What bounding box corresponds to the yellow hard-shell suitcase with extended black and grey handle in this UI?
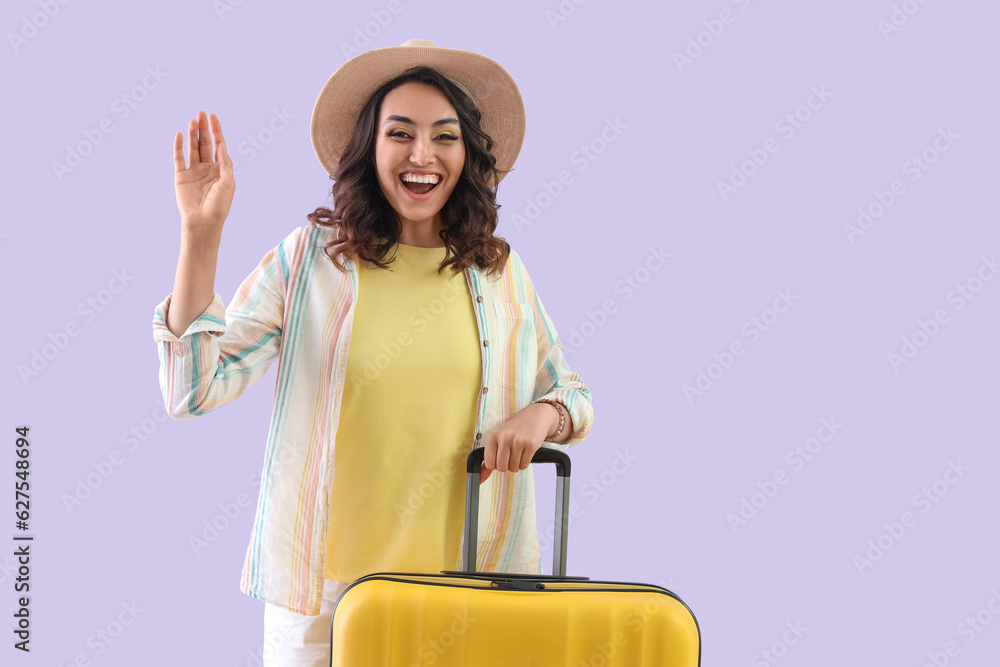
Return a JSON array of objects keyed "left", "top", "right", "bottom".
[{"left": 330, "top": 447, "right": 701, "bottom": 667}]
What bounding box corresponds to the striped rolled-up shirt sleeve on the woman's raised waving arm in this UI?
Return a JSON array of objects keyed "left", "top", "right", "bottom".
[{"left": 153, "top": 239, "right": 288, "bottom": 419}]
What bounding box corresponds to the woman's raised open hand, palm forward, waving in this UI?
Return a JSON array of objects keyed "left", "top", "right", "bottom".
[{"left": 174, "top": 111, "right": 236, "bottom": 238}]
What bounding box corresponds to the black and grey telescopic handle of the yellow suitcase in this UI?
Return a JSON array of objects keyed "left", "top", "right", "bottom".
[{"left": 462, "top": 446, "right": 570, "bottom": 577}]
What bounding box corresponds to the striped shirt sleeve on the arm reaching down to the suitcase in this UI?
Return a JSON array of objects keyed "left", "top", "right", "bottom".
[{"left": 511, "top": 251, "right": 594, "bottom": 450}]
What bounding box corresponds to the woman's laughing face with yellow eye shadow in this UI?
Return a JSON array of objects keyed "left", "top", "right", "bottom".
[{"left": 375, "top": 83, "right": 465, "bottom": 238}]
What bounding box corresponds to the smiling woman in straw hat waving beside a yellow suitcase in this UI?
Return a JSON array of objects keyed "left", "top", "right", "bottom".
[{"left": 153, "top": 40, "right": 593, "bottom": 667}]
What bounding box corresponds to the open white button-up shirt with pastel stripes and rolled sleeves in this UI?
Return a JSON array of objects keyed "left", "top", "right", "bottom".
[{"left": 153, "top": 225, "right": 593, "bottom": 616}]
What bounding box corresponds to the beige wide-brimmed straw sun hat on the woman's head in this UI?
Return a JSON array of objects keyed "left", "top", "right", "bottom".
[{"left": 309, "top": 39, "right": 525, "bottom": 182}]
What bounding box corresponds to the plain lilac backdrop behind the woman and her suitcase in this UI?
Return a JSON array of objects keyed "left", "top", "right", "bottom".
[{"left": 0, "top": 0, "right": 1000, "bottom": 667}]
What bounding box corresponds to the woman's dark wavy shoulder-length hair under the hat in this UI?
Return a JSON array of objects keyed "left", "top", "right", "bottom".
[{"left": 306, "top": 66, "right": 510, "bottom": 275}]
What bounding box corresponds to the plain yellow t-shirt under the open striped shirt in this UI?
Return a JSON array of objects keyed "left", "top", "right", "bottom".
[{"left": 324, "top": 243, "right": 482, "bottom": 581}]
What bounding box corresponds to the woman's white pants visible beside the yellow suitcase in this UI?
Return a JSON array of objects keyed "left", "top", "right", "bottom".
[{"left": 264, "top": 579, "right": 351, "bottom": 667}]
